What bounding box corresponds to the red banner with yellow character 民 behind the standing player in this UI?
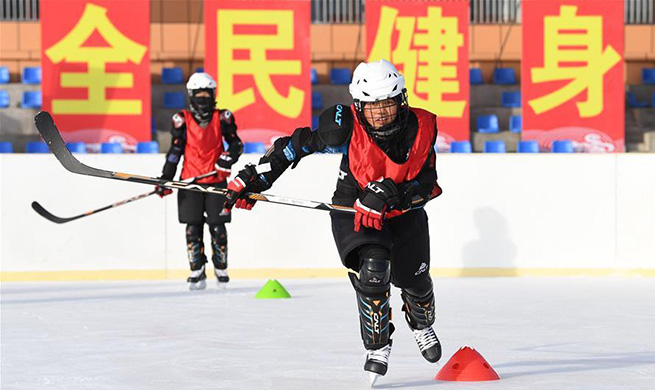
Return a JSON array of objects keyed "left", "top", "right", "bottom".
[{"left": 204, "top": 0, "right": 312, "bottom": 145}]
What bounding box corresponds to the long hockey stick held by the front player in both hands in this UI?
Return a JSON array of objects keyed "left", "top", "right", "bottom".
[{"left": 34, "top": 111, "right": 355, "bottom": 214}]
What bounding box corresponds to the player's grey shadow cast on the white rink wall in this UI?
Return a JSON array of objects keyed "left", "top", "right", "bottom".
[{"left": 459, "top": 207, "right": 517, "bottom": 276}]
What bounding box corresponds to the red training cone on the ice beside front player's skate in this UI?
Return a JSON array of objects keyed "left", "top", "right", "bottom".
[{"left": 434, "top": 346, "right": 500, "bottom": 382}]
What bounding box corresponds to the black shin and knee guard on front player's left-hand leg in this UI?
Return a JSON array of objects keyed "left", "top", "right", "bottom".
[{"left": 348, "top": 259, "right": 393, "bottom": 349}]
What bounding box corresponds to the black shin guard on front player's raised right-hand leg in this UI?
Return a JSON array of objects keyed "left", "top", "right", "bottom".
[{"left": 401, "top": 276, "right": 434, "bottom": 330}]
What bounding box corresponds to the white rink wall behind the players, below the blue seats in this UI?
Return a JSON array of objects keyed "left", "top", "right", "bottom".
[{"left": 0, "top": 154, "right": 655, "bottom": 275}]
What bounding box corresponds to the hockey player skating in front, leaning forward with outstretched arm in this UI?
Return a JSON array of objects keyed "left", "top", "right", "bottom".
[{"left": 226, "top": 60, "right": 441, "bottom": 385}]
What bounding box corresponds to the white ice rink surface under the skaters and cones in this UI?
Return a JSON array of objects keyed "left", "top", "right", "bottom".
[{"left": 0, "top": 278, "right": 655, "bottom": 390}]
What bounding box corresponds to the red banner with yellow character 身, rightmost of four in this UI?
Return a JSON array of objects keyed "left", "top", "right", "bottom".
[{"left": 521, "top": 0, "right": 625, "bottom": 152}]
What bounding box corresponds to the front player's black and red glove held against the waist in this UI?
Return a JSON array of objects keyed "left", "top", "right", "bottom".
[{"left": 354, "top": 178, "right": 399, "bottom": 232}]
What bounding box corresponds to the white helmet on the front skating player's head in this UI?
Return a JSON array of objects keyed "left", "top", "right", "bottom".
[{"left": 348, "top": 60, "right": 405, "bottom": 104}]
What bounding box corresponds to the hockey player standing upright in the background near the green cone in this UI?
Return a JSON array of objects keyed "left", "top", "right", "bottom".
[{"left": 157, "top": 73, "right": 243, "bottom": 290}]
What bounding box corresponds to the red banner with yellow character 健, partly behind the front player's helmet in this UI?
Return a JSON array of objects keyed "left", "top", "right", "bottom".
[{"left": 366, "top": 0, "right": 469, "bottom": 150}]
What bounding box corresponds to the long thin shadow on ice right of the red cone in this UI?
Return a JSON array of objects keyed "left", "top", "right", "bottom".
[{"left": 494, "top": 351, "right": 655, "bottom": 378}]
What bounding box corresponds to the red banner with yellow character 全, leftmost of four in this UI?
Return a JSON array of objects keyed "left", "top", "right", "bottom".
[{"left": 41, "top": 0, "right": 151, "bottom": 150}]
